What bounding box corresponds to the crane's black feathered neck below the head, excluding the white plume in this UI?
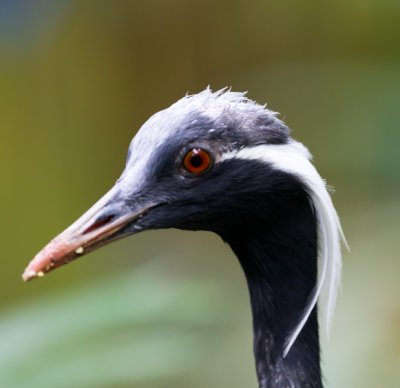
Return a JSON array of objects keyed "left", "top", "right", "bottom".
[{"left": 225, "top": 195, "right": 322, "bottom": 388}]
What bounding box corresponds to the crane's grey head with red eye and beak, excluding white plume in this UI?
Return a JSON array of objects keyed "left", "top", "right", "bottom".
[{"left": 23, "top": 90, "right": 289, "bottom": 280}]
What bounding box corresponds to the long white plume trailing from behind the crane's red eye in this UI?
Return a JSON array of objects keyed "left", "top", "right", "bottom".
[{"left": 221, "top": 141, "right": 348, "bottom": 357}]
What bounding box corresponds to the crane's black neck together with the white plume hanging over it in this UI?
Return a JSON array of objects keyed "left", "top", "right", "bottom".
[{"left": 222, "top": 141, "right": 344, "bottom": 388}]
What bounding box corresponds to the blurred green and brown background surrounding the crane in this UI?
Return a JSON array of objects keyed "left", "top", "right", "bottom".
[{"left": 0, "top": 0, "right": 400, "bottom": 388}]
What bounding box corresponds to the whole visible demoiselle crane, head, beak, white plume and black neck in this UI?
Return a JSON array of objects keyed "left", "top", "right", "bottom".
[{"left": 23, "top": 88, "right": 345, "bottom": 388}]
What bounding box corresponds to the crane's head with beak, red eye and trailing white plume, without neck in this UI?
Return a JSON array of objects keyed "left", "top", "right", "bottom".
[{"left": 23, "top": 88, "right": 343, "bottom": 349}]
